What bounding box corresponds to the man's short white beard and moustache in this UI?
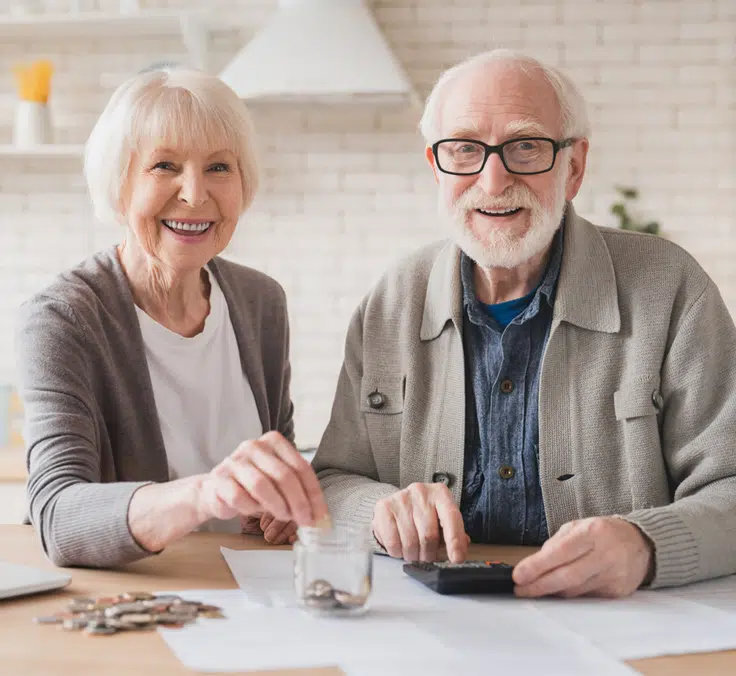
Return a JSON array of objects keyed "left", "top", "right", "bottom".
[{"left": 439, "top": 162, "right": 569, "bottom": 268}]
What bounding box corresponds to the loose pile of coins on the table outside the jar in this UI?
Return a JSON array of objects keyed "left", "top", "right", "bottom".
[{"left": 33, "top": 592, "right": 225, "bottom": 636}]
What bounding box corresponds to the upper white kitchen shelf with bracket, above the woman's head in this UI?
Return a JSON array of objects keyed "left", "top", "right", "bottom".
[{"left": 0, "top": 10, "right": 212, "bottom": 69}]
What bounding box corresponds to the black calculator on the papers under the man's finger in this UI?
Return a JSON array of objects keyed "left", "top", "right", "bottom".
[{"left": 404, "top": 561, "right": 514, "bottom": 594}]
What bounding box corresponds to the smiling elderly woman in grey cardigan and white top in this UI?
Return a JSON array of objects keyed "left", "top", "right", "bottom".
[{"left": 17, "top": 69, "right": 326, "bottom": 567}]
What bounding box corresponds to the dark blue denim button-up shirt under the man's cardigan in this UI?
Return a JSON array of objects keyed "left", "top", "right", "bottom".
[{"left": 460, "top": 228, "right": 562, "bottom": 545}]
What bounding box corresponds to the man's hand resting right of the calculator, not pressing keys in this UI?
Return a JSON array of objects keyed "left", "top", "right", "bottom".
[{"left": 514, "top": 516, "right": 654, "bottom": 598}]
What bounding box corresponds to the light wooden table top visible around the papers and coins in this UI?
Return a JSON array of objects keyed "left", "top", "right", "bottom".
[{"left": 0, "top": 526, "right": 736, "bottom": 676}]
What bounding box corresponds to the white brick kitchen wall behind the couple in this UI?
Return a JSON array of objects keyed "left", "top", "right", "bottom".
[{"left": 0, "top": 0, "right": 736, "bottom": 445}]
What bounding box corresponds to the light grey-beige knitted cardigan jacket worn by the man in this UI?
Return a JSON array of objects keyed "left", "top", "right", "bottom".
[{"left": 313, "top": 208, "right": 736, "bottom": 586}]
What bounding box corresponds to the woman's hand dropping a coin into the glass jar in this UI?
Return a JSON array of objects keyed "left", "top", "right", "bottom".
[{"left": 199, "top": 432, "right": 327, "bottom": 531}]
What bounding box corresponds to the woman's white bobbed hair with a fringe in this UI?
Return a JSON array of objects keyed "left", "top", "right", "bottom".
[{"left": 84, "top": 67, "right": 258, "bottom": 223}]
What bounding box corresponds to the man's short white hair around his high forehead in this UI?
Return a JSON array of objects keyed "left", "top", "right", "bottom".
[{"left": 419, "top": 49, "right": 590, "bottom": 145}]
